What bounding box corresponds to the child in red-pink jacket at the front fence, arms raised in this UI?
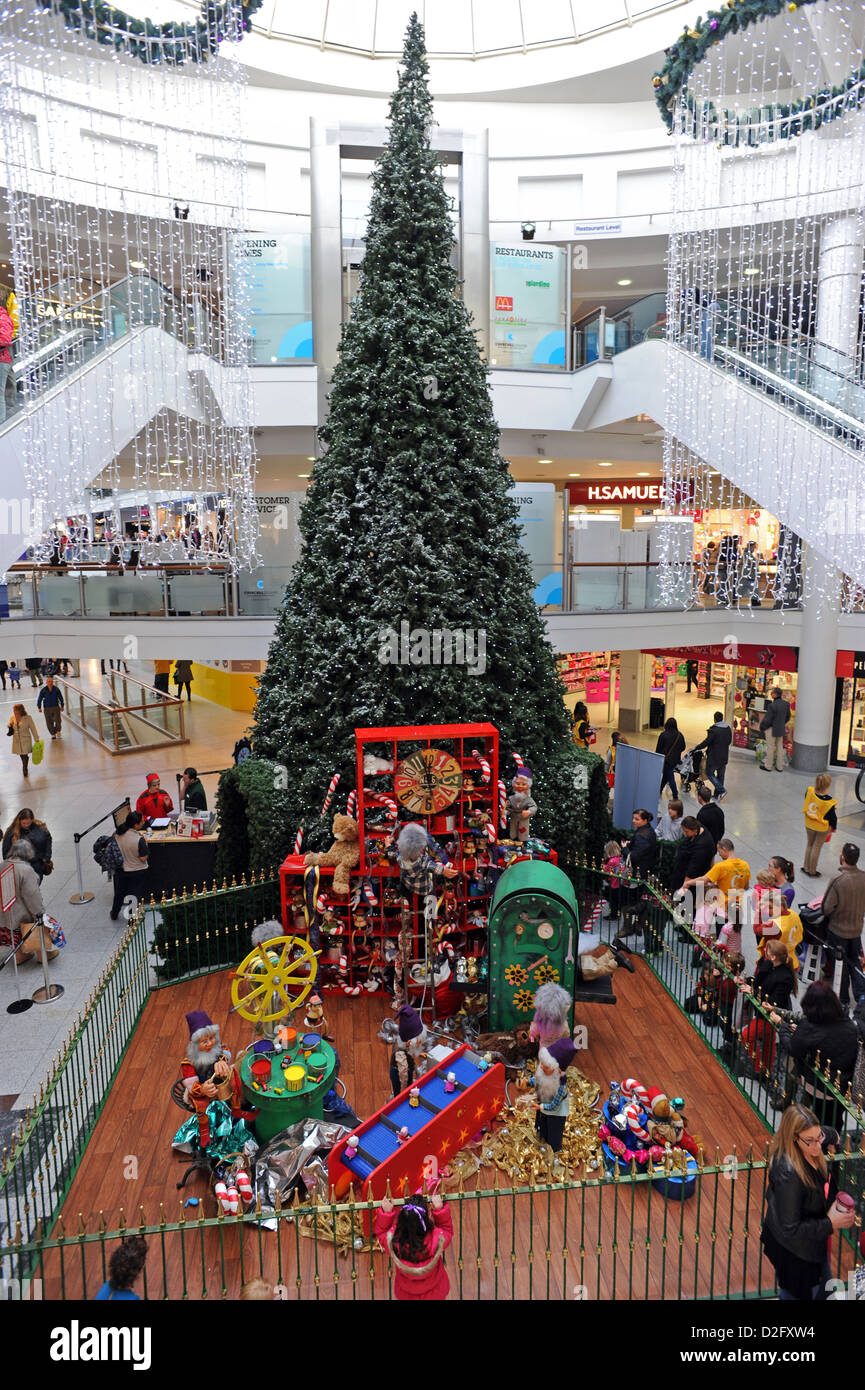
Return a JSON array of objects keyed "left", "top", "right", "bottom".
[{"left": 375, "top": 1195, "right": 453, "bottom": 1302}]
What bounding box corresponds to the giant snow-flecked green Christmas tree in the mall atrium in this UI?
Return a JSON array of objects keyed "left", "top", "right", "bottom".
[{"left": 246, "top": 17, "right": 606, "bottom": 863}]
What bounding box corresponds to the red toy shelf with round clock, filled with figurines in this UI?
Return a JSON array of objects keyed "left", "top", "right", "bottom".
[{"left": 280, "top": 724, "right": 501, "bottom": 1002}]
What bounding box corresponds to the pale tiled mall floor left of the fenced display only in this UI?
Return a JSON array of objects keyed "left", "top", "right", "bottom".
[{"left": 0, "top": 662, "right": 250, "bottom": 1108}]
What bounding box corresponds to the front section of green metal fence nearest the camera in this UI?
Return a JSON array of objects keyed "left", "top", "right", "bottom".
[{"left": 4, "top": 1154, "right": 865, "bottom": 1301}]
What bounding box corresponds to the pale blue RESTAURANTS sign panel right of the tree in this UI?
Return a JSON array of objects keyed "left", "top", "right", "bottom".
[{"left": 490, "top": 242, "right": 566, "bottom": 371}]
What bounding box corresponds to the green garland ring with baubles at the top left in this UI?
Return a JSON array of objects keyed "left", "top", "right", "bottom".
[{"left": 38, "top": 0, "right": 264, "bottom": 67}]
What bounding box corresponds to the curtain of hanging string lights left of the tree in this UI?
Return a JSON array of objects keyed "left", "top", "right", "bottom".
[{"left": 0, "top": 0, "right": 257, "bottom": 569}]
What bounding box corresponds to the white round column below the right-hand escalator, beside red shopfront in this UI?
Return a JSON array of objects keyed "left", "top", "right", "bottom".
[{"left": 795, "top": 549, "right": 841, "bottom": 773}]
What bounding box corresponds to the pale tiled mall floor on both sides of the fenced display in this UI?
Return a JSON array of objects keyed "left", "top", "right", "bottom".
[{"left": 0, "top": 662, "right": 865, "bottom": 1108}]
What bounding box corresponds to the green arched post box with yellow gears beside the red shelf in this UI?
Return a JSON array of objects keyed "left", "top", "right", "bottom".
[{"left": 490, "top": 859, "right": 580, "bottom": 1030}]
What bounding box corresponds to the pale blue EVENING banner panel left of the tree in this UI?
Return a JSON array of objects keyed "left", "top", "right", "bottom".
[{"left": 234, "top": 232, "right": 313, "bottom": 367}]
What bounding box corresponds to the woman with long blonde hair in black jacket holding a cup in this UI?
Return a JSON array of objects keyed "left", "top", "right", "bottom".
[{"left": 759, "top": 1105, "right": 855, "bottom": 1302}]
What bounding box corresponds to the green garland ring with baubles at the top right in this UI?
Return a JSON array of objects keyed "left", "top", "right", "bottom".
[{"left": 652, "top": 0, "right": 865, "bottom": 146}]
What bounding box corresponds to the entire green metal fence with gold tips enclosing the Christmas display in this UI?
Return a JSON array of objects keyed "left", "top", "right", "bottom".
[{"left": 0, "top": 865, "right": 865, "bottom": 1298}]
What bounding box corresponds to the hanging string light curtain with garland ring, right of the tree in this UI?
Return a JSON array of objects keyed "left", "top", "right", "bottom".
[{"left": 655, "top": 0, "right": 865, "bottom": 607}]
